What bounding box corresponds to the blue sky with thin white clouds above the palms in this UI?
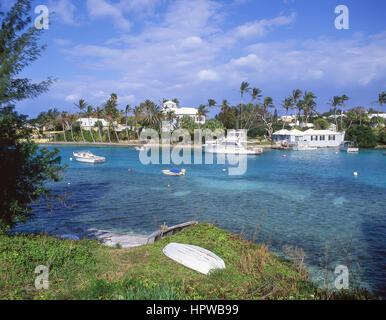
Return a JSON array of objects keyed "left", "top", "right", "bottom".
[{"left": 0, "top": 0, "right": 386, "bottom": 117}]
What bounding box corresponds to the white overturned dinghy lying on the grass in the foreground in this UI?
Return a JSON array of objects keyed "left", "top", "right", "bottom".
[{"left": 162, "top": 242, "right": 225, "bottom": 275}]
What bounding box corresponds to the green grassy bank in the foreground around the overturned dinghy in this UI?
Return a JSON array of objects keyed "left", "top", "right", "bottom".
[{"left": 0, "top": 223, "right": 374, "bottom": 299}]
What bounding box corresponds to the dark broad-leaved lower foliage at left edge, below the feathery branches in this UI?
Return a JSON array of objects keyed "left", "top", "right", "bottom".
[{"left": 0, "top": 107, "right": 64, "bottom": 232}]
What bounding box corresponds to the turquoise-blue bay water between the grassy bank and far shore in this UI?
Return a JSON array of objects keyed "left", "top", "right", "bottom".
[{"left": 13, "top": 146, "right": 386, "bottom": 296}]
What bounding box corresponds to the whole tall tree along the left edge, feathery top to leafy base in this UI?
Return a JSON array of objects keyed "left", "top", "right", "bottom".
[{"left": 0, "top": 0, "right": 63, "bottom": 232}]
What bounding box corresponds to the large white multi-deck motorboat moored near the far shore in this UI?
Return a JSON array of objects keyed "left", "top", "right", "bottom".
[{"left": 204, "top": 139, "right": 263, "bottom": 155}]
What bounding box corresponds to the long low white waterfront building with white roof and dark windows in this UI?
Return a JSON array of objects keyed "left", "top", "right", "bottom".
[{"left": 272, "top": 129, "right": 345, "bottom": 148}]
